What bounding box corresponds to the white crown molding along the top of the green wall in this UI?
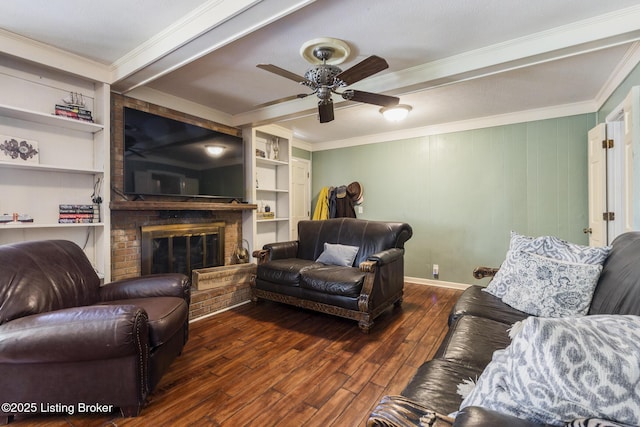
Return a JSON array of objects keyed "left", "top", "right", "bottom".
[{"left": 311, "top": 101, "right": 596, "bottom": 152}]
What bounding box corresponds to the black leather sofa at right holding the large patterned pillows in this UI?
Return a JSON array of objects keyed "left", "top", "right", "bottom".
[{"left": 367, "top": 232, "right": 640, "bottom": 427}]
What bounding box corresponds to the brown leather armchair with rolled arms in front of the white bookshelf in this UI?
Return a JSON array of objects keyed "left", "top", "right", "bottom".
[{"left": 0, "top": 240, "right": 190, "bottom": 424}]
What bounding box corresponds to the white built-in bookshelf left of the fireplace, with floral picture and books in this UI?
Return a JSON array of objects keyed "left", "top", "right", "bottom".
[{"left": 0, "top": 63, "right": 111, "bottom": 283}]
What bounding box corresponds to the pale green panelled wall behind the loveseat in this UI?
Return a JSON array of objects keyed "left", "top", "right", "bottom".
[{"left": 312, "top": 114, "right": 596, "bottom": 283}]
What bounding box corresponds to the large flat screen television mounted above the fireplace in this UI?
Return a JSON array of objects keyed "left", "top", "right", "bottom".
[{"left": 124, "top": 107, "right": 245, "bottom": 201}]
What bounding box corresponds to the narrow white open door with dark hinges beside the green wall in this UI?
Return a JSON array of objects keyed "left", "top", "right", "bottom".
[{"left": 585, "top": 123, "right": 607, "bottom": 246}]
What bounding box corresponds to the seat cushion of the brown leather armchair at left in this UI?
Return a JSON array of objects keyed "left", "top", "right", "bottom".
[{"left": 101, "top": 297, "right": 189, "bottom": 348}]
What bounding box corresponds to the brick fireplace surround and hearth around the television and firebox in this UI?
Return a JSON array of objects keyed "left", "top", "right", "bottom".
[{"left": 111, "top": 93, "right": 250, "bottom": 319}]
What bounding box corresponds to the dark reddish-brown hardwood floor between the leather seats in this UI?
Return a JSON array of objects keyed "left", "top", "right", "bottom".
[{"left": 10, "top": 284, "right": 461, "bottom": 427}]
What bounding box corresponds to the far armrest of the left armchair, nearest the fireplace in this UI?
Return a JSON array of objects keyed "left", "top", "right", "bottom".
[{"left": 100, "top": 273, "right": 191, "bottom": 303}]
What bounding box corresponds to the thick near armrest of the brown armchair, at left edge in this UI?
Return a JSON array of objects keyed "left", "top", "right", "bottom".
[{"left": 0, "top": 305, "right": 148, "bottom": 364}]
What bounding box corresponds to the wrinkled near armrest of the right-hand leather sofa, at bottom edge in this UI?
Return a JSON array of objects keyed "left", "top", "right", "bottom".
[{"left": 367, "top": 396, "right": 452, "bottom": 427}]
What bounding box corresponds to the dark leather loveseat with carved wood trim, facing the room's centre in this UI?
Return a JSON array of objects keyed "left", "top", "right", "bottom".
[{"left": 251, "top": 218, "right": 412, "bottom": 332}]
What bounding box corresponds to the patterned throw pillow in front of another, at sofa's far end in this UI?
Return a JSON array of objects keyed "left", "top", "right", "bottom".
[{"left": 500, "top": 252, "right": 602, "bottom": 317}]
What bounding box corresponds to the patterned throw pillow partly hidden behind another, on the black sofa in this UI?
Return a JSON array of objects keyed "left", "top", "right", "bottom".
[{"left": 483, "top": 231, "right": 611, "bottom": 306}]
